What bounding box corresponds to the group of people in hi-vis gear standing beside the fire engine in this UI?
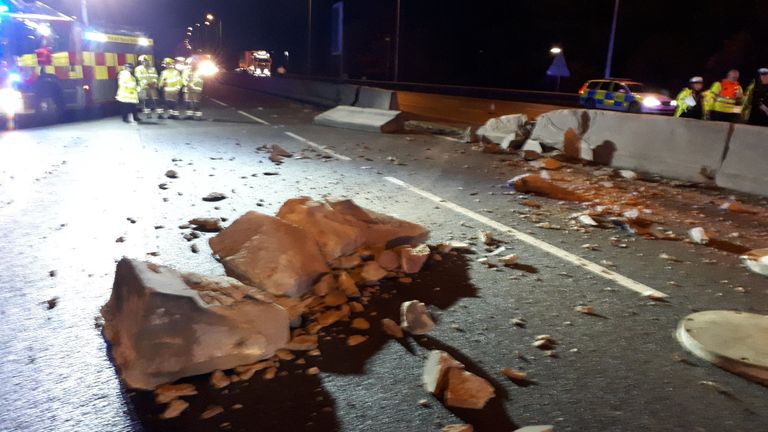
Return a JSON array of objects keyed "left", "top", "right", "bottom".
[{"left": 115, "top": 55, "right": 204, "bottom": 124}]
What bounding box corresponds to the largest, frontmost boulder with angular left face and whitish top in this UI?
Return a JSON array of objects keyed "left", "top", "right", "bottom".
[{"left": 101, "top": 258, "right": 289, "bottom": 389}]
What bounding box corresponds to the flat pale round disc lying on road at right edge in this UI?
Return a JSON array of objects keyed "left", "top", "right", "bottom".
[{"left": 677, "top": 311, "right": 768, "bottom": 385}]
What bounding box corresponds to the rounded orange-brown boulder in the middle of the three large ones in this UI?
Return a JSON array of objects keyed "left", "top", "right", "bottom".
[{"left": 209, "top": 211, "right": 330, "bottom": 297}]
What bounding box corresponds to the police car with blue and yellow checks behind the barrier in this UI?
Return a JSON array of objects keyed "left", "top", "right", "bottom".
[{"left": 579, "top": 79, "right": 677, "bottom": 115}]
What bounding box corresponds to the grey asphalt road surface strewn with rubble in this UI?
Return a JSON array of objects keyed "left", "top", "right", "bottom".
[{"left": 0, "top": 82, "right": 768, "bottom": 432}]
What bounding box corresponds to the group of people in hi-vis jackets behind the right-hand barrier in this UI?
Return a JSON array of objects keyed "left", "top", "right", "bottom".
[{"left": 675, "top": 68, "right": 768, "bottom": 126}]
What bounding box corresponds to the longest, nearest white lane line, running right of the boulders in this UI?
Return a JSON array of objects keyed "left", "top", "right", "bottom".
[{"left": 384, "top": 177, "right": 668, "bottom": 298}]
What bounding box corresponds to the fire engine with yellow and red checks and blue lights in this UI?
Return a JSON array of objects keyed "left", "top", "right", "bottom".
[{"left": 0, "top": 0, "right": 154, "bottom": 123}]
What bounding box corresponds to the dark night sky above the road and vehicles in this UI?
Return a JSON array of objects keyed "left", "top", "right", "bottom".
[{"left": 39, "top": 0, "right": 768, "bottom": 91}]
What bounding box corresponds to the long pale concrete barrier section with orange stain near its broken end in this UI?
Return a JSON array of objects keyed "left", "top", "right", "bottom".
[{"left": 530, "top": 109, "right": 730, "bottom": 182}]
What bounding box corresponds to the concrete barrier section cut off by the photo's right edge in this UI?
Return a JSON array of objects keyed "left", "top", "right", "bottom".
[{"left": 715, "top": 125, "right": 768, "bottom": 196}]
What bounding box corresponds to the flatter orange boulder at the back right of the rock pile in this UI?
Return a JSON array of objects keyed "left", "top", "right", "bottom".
[{"left": 277, "top": 197, "right": 429, "bottom": 261}]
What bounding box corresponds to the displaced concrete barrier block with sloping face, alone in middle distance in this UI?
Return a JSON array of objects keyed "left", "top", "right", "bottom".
[{"left": 315, "top": 105, "right": 403, "bottom": 133}]
